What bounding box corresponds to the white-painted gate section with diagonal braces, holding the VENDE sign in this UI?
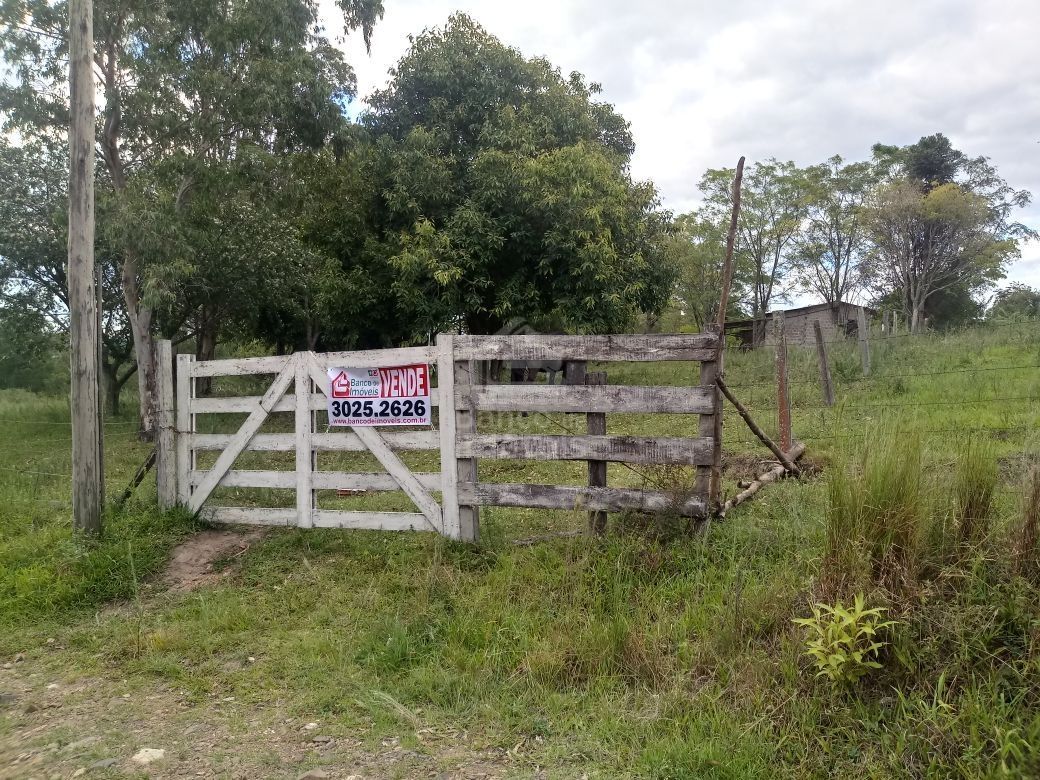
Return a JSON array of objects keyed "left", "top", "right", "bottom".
[{"left": 160, "top": 347, "right": 460, "bottom": 538}]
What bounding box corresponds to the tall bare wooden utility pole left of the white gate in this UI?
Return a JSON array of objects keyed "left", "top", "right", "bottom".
[{"left": 68, "top": 0, "right": 105, "bottom": 536}]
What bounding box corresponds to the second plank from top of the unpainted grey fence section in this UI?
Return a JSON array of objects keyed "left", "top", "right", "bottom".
[{"left": 454, "top": 385, "right": 714, "bottom": 414}]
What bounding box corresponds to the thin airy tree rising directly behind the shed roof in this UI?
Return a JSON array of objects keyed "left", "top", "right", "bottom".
[{"left": 791, "top": 156, "right": 877, "bottom": 312}]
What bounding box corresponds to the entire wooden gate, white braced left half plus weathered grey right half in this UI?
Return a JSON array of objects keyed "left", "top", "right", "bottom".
[{"left": 159, "top": 333, "right": 722, "bottom": 540}]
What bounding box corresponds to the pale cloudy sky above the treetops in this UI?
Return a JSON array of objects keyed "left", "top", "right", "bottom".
[{"left": 326, "top": 0, "right": 1040, "bottom": 286}]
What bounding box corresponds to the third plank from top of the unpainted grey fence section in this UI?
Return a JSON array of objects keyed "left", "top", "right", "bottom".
[{"left": 459, "top": 434, "right": 714, "bottom": 463}]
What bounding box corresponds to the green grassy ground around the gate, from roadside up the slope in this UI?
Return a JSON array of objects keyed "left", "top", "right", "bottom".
[{"left": 0, "top": 322, "right": 1040, "bottom": 778}]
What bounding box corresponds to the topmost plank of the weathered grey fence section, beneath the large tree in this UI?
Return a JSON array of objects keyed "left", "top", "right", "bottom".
[{"left": 454, "top": 333, "right": 719, "bottom": 362}]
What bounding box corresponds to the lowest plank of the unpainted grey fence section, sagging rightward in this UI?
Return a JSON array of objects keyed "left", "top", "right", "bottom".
[{"left": 459, "top": 483, "right": 706, "bottom": 517}]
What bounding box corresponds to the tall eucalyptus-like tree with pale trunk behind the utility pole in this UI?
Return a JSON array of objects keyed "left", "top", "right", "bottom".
[{"left": 0, "top": 0, "right": 383, "bottom": 435}]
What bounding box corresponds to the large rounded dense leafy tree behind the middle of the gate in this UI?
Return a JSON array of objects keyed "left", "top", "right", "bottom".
[{"left": 363, "top": 15, "right": 671, "bottom": 338}]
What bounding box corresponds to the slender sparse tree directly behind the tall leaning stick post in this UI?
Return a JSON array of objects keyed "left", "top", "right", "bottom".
[{"left": 700, "top": 159, "right": 807, "bottom": 341}]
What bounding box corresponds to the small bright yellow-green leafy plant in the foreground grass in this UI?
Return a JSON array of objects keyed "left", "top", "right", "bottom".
[{"left": 795, "top": 594, "right": 895, "bottom": 684}]
